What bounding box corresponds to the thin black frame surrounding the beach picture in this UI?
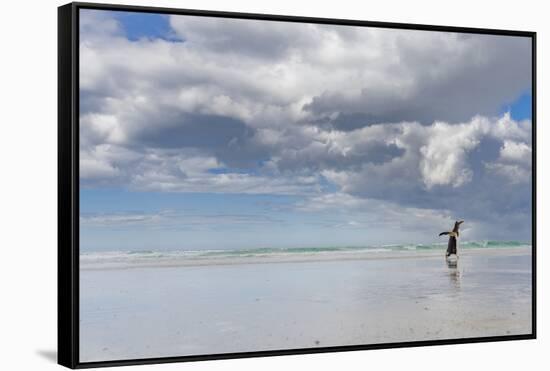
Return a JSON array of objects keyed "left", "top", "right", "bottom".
[{"left": 58, "top": 2, "right": 537, "bottom": 368}]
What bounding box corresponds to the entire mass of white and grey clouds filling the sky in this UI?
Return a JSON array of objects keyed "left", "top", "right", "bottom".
[{"left": 80, "top": 10, "right": 532, "bottom": 241}]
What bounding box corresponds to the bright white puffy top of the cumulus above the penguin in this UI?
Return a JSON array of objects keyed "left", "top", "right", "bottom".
[{"left": 323, "top": 114, "right": 530, "bottom": 192}]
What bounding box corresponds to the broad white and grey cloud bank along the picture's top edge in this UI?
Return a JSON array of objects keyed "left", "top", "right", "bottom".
[{"left": 81, "top": 12, "right": 530, "bottom": 140}]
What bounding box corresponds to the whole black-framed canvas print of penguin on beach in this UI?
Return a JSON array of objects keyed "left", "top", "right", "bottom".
[{"left": 58, "top": 3, "right": 536, "bottom": 368}]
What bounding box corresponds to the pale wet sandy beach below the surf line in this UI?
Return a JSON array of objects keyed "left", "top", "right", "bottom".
[{"left": 80, "top": 247, "right": 531, "bottom": 362}]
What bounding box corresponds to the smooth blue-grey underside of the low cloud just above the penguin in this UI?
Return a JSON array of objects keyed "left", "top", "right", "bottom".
[{"left": 334, "top": 163, "right": 532, "bottom": 240}]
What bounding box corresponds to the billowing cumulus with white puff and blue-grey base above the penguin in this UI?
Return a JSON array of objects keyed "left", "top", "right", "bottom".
[{"left": 322, "top": 115, "right": 531, "bottom": 238}]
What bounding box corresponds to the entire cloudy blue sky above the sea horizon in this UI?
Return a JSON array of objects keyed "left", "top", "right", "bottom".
[{"left": 80, "top": 10, "right": 532, "bottom": 251}]
